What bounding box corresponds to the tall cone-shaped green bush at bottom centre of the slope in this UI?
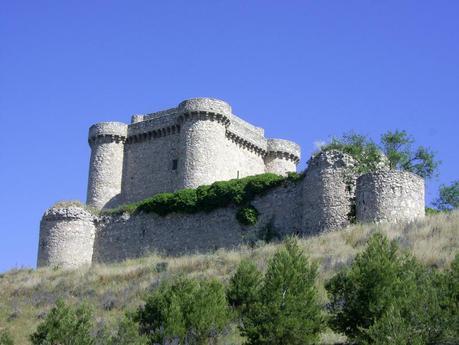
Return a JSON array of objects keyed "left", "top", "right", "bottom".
[{"left": 241, "top": 239, "right": 324, "bottom": 345}]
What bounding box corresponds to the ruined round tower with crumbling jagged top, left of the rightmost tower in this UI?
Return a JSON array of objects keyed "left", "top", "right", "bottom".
[{"left": 303, "top": 150, "right": 356, "bottom": 234}]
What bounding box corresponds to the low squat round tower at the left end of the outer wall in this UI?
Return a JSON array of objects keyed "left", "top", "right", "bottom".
[{"left": 37, "top": 203, "right": 96, "bottom": 268}]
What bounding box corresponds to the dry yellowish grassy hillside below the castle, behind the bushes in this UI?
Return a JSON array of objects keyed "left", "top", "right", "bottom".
[{"left": 0, "top": 212, "right": 459, "bottom": 344}]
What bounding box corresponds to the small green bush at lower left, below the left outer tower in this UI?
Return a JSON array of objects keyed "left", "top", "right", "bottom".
[{"left": 30, "top": 300, "right": 94, "bottom": 345}]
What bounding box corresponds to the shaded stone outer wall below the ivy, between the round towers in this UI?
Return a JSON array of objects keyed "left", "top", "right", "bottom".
[{"left": 93, "top": 183, "right": 302, "bottom": 262}]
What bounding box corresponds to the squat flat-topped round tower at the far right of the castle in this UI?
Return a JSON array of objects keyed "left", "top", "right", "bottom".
[{"left": 356, "top": 170, "right": 425, "bottom": 222}]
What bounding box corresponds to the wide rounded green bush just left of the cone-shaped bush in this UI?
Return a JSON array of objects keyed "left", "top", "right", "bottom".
[{"left": 136, "top": 278, "right": 230, "bottom": 344}]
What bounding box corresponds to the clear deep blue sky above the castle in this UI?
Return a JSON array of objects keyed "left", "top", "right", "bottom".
[{"left": 0, "top": 0, "right": 459, "bottom": 271}]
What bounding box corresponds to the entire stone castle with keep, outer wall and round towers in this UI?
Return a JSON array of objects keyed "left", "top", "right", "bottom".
[{"left": 38, "top": 98, "right": 425, "bottom": 267}]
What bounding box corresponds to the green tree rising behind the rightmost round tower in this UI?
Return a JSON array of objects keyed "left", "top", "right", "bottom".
[{"left": 381, "top": 130, "right": 439, "bottom": 178}]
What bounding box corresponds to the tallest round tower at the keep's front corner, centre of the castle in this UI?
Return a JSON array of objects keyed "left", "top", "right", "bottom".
[{"left": 178, "top": 98, "right": 231, "bottom": 188}]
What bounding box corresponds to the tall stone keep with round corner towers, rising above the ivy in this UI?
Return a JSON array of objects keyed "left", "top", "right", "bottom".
[{"left": 87, "top": 98, "right": 300, "bottom": 208}]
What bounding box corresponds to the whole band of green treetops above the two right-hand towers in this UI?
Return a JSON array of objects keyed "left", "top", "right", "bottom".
[{"left": 321, "top": 130, "right": 440, "bottom": 178}]
